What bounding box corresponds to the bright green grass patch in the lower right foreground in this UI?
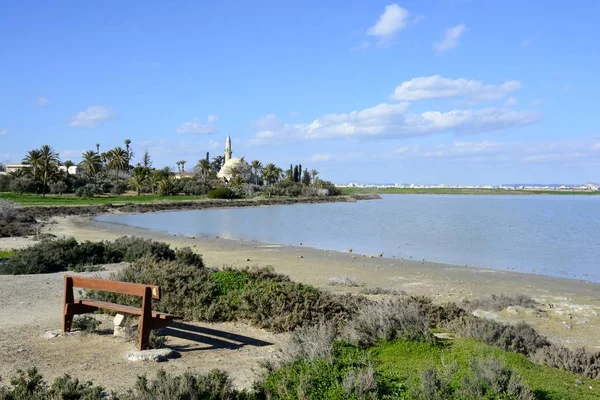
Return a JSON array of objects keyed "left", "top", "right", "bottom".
[{"left": 369, "top": 339, "right": 600, "bottom": 400}]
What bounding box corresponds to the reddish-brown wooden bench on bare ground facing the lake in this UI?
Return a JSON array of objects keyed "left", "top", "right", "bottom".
[{"left": 63, "top": 275, "right": 182, "bottom": 350}]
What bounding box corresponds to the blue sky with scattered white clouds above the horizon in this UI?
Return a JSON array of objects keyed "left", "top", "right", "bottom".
[{"left": 0, "top": 0, "right": 600, "bottom": 184}]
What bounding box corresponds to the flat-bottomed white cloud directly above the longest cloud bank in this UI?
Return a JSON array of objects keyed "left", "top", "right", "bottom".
[{"left": 390, "top": 75, "right": 523, "bottom": 102}]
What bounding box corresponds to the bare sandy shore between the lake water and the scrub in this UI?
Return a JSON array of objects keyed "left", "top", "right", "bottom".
[{"left": 16, "top": 216, "right": 600, "bottom": 351}]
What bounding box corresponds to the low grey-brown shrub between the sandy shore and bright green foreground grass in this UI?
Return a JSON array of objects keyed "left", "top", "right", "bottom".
[{"left": 446, "top": 315, "right": 550, "bottom": 356}]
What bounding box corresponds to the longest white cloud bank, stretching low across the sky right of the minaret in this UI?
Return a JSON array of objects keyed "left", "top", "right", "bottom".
[{"left": 252, "top": 103, "right": 541, "bottom": 144}]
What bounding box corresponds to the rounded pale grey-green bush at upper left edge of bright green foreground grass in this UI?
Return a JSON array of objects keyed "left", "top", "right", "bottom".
[{"left": 342, "top": 300, "right": 435, "bottom": 348}]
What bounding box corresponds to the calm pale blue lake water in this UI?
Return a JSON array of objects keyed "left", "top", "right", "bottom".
[{"left": 98, "top": 195, "right": 600, "bottom": 282}]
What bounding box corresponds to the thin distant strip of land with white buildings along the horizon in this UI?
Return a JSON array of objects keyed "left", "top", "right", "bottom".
[{"left": 341, "top": 187, "right": 600, "bottom": 196}]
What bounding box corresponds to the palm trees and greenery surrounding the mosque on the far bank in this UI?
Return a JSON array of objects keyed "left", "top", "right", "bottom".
[{"left": 0, "top": 139, "right": 341, "bottom": 204}]
